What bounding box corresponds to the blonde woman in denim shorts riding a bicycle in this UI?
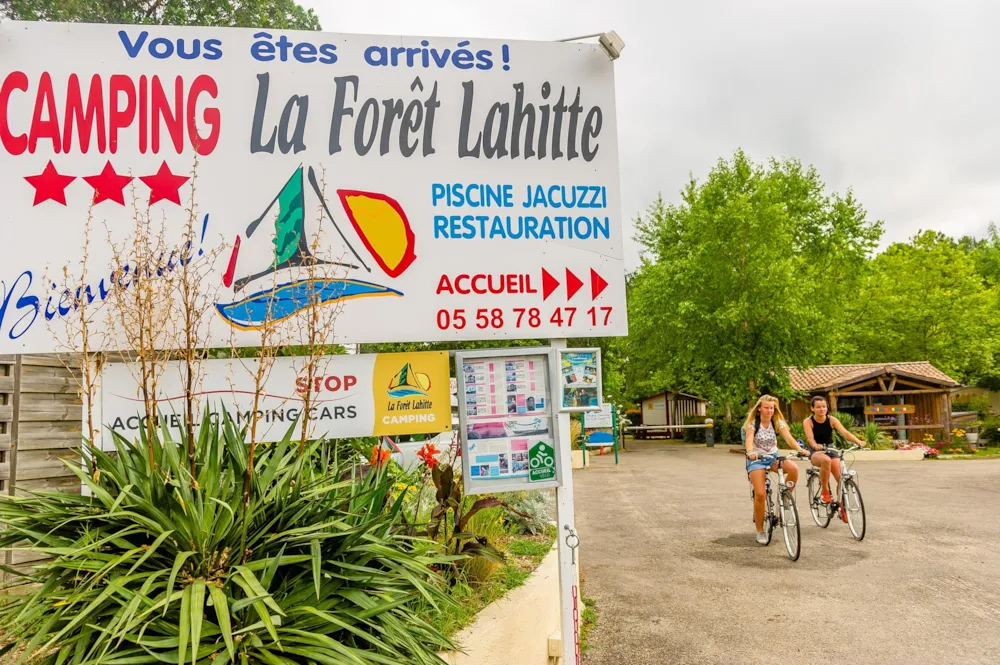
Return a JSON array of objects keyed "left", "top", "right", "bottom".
[{"left": 743, "top": 395, "right": 805, "bottom": 545}]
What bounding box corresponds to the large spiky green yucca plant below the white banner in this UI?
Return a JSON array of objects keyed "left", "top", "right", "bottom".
[{"left": 0, "top": 417, "right": 454, "bottom": 665}]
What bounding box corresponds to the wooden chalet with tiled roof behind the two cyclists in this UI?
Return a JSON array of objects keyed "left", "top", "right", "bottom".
[{"left": 781, "top": 361, "right": 961, "bottom": 442}]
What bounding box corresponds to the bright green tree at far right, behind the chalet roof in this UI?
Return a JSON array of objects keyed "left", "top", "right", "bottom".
[{"left": 852, "top": 231, "right": 1000, "bottom": 383}]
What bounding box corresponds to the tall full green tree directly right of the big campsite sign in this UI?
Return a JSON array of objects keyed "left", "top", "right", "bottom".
[{"left": 625, "top": 151, "right": 882, "bottom": 411}]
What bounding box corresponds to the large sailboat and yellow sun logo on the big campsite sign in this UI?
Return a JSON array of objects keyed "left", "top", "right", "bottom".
[{"left": 216, "top": 166, "right": 416, "bottom": 330}]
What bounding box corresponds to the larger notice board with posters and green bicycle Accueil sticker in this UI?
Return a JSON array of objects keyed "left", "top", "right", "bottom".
[{"left": 455, "top": 347, "right": 562, "bottom": 494}]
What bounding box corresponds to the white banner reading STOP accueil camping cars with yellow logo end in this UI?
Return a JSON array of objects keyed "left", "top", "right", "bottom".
[{"left": 100, "top": 351, "right": 451, "bottom": 448}]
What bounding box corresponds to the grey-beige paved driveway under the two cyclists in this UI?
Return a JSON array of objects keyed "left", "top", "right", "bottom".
[{"left": 574, "top": 443, "right": 1000, "bottom": 665}]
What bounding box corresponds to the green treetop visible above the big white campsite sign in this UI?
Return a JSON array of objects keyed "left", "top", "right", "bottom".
[{"left": 0, "top": 0, "right": 320, "bottom": 30}]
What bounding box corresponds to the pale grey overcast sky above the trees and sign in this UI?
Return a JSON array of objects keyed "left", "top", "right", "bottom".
[{"left": 300, "top": 0, "right": 1000, "bottom": 269}]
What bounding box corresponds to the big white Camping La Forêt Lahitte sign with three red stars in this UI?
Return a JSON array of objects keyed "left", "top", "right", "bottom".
[{"left": 0, "top": 22, "right": 627, "bottom": 353}]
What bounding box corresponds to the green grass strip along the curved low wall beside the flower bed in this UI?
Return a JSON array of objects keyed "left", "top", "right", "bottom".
[{"left": 424, "top": 526, "right": 556, "bottom": 637}]
